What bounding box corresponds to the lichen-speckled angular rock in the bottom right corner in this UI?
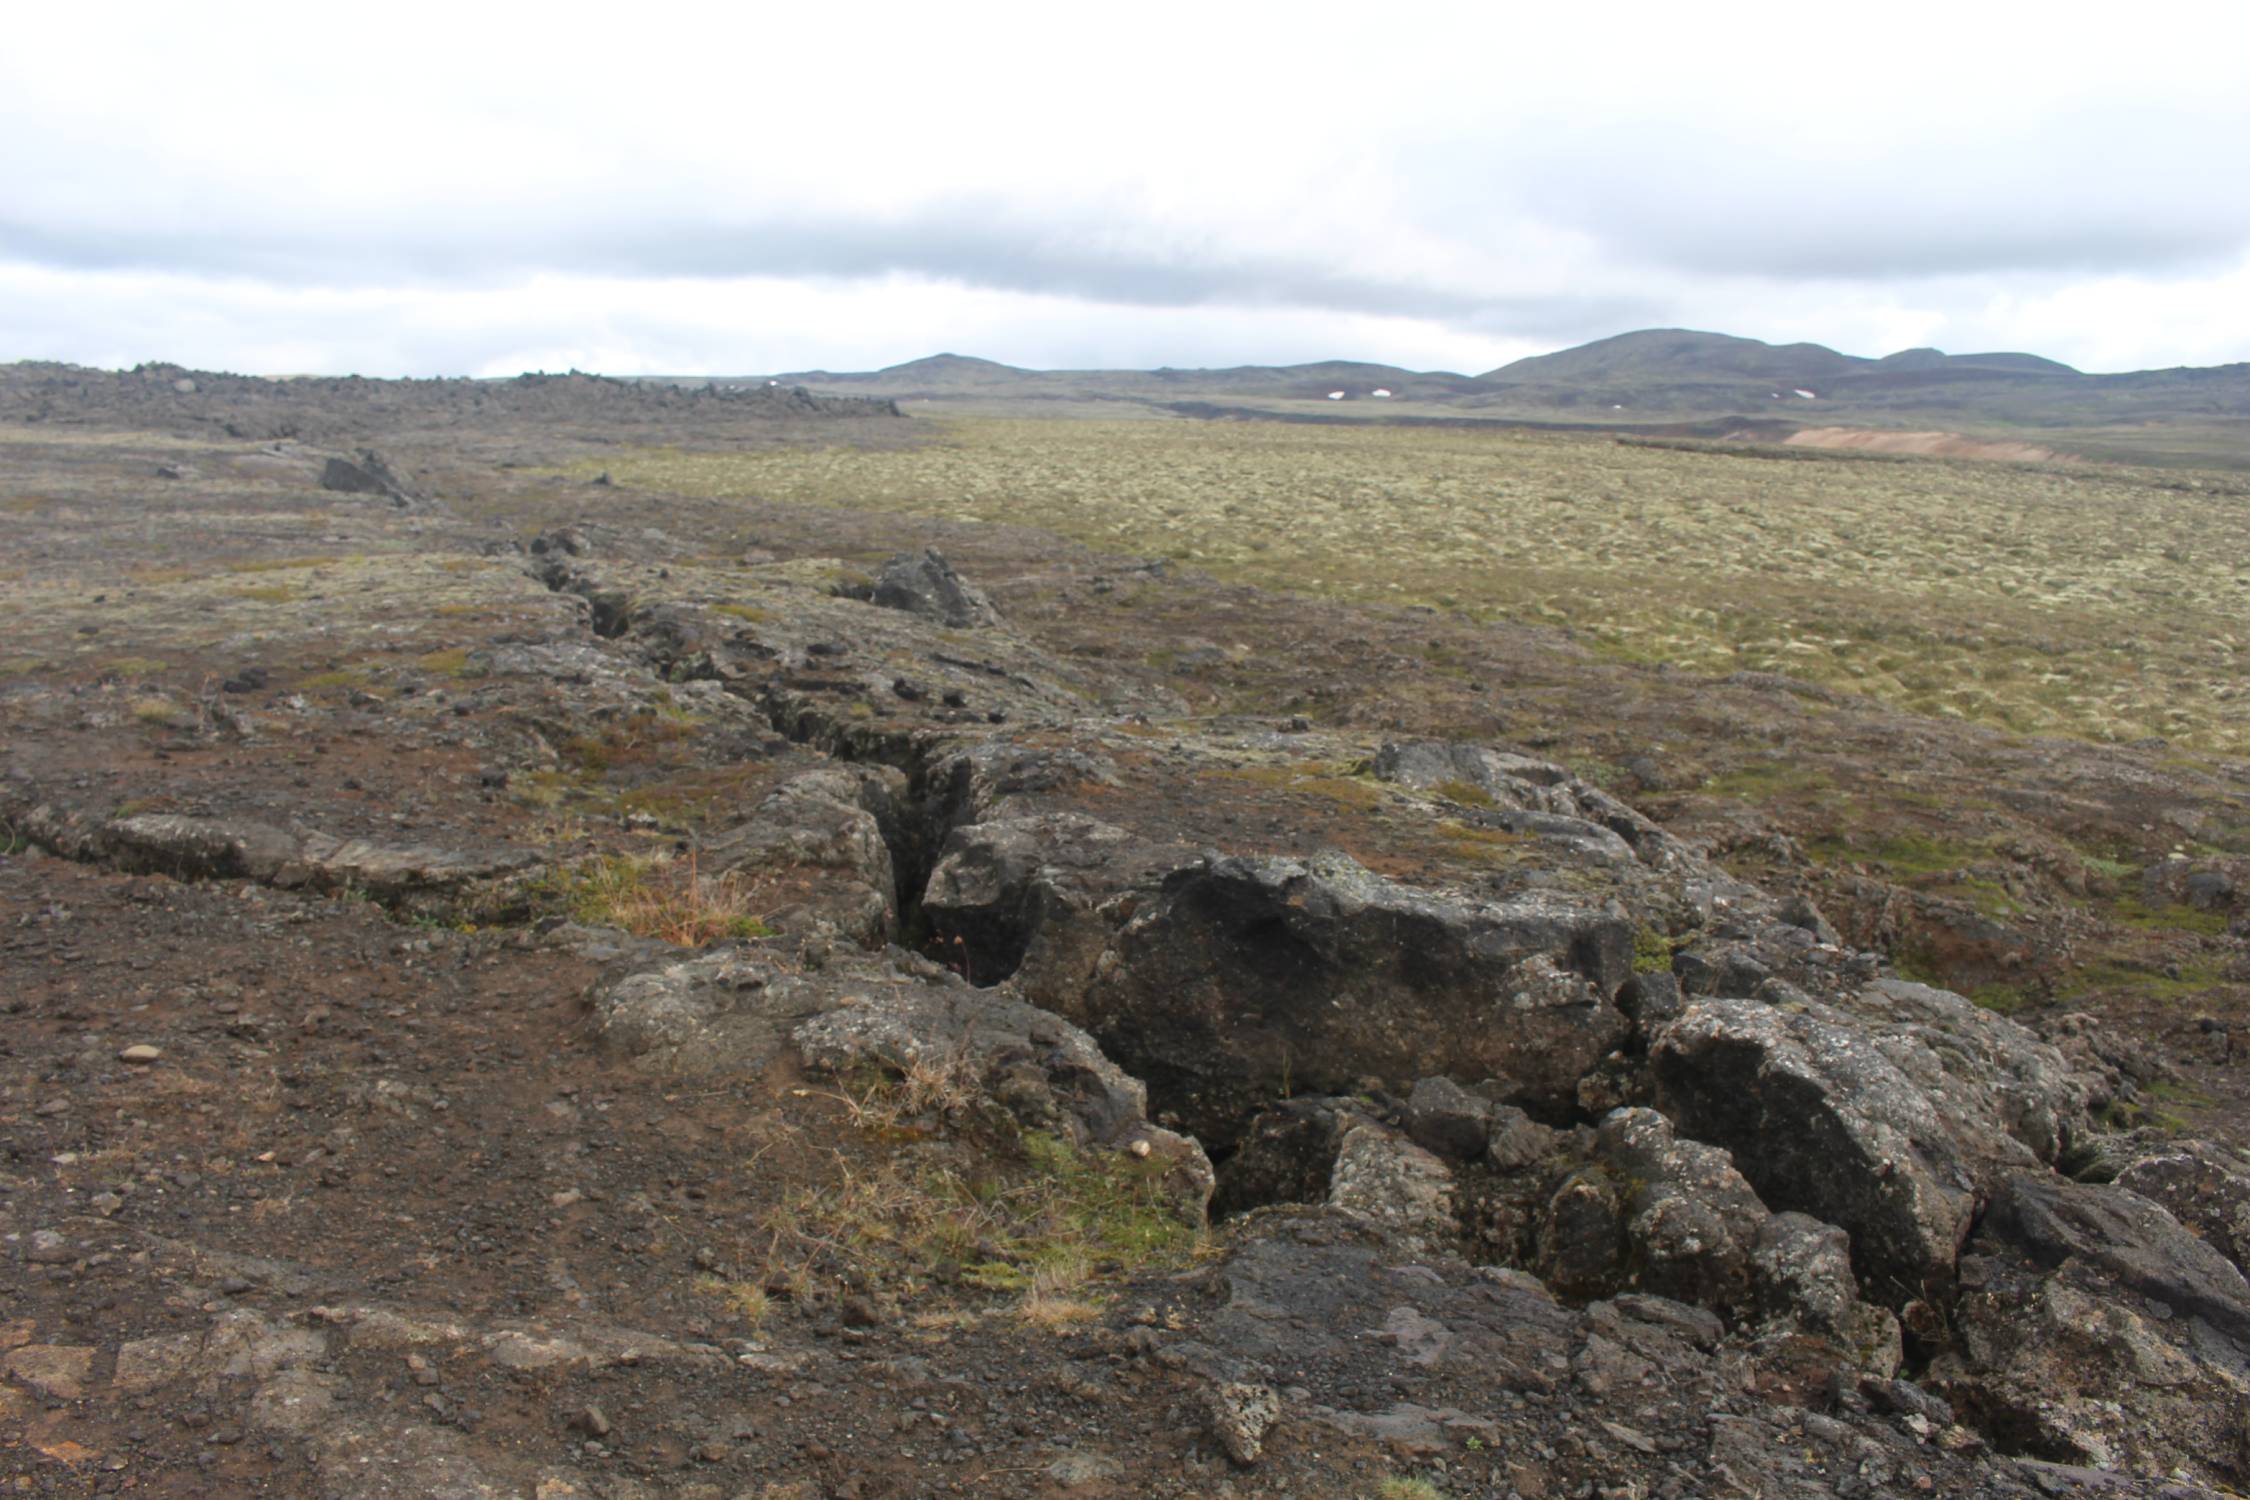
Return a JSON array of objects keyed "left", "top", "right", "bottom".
[{"left": 1928, "top": 1176, "right": 2250, "bottom": 1489}]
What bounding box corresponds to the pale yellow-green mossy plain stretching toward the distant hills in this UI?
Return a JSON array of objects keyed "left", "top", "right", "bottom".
[{"left": 558, "top": 418, "right": 2250, "bottom": 756}]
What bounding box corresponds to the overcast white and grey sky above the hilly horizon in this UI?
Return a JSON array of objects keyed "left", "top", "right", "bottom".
[{"left": 0, "top": 0, "right": 2250, "bottom": 376}]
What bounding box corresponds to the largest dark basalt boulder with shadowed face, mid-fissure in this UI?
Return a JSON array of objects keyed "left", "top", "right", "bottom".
[{"left": 1058, "top": 855, "right": 1634, "bottom": 1151}]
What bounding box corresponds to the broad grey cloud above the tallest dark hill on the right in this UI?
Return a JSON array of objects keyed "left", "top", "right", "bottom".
[{"left": 1400, "top": 110, "right": 2250, "bottom": 283}]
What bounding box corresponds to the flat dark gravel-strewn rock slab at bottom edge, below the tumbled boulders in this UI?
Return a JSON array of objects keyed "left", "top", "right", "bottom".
[{"left": 1172, "top": 1210, "right": 2061, "bottom": 1500}]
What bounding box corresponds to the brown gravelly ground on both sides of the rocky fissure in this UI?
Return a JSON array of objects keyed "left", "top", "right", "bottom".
[{"left": 0, "top": 371, "right": 2250, "bottom": 1500}]
